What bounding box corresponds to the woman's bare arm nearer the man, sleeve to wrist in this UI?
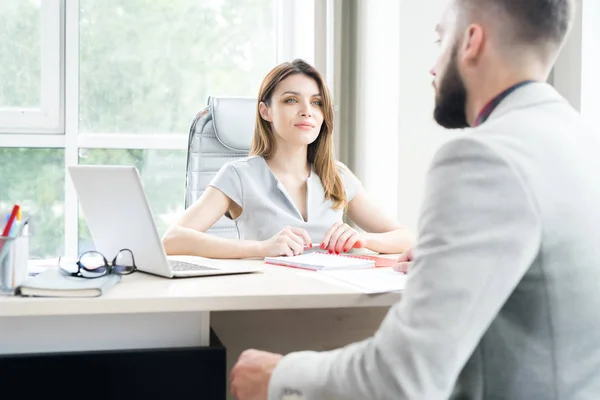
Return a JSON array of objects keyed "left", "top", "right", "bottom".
[{"left": 348, "top": 189, "right": 415, "bottom": 253}]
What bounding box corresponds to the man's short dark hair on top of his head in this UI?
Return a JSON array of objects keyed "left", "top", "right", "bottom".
[{"left": 460, "top": 0, "right": 575, "bottom": 44}]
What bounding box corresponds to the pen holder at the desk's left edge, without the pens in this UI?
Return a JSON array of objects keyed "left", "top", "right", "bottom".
[{"left": 0, "top": 235, "right": 29, "bottom": 295}]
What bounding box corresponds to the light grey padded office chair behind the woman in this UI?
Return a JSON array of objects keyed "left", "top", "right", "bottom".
[{"left": 185, "top": 96, "right": 256, "bottom": 238}]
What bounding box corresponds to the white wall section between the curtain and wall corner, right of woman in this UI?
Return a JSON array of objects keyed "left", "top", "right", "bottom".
[{"left": 352, "top": 0, "right": 400, "bottom": 217}]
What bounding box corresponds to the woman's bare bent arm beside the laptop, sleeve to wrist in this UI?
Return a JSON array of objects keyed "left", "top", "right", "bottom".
[{"left": 162, "top": 186, "right": 264, "bottom": 258}]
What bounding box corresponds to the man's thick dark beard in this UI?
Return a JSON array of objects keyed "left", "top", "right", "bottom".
[{"left": 433, "top": 46, "right": 469, "bottom": 129}]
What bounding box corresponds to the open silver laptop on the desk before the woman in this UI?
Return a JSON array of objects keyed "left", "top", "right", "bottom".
[{"left": 68, "top": 165, "right": 261, "bottom": 278}]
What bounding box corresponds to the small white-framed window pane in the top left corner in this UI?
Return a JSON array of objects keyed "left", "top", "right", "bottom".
[{"left": 0, "top": 0, "right": 62, "bottom": 133}]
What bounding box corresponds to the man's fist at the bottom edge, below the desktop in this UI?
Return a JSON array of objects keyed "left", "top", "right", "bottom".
[{"left": 231, "top": 350, "right": 283, "bottom": 400}]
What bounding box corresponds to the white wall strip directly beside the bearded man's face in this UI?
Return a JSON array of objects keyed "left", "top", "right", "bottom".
[{"left": 397, "top": 0, "right": 454, "bottom": 232}]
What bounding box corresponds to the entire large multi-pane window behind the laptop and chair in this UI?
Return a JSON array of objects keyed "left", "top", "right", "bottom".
[{"left": 0, "top": 0, "right": 313, "bottom": 258}]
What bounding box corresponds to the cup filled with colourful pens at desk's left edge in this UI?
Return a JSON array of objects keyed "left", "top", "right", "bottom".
[{"left": 0, "top": 205, "right": 29, "bottom": 295}]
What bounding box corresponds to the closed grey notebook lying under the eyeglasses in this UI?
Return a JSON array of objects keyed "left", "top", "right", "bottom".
[{"left": 17, "top": 268, "right": 121, "bottom": 297}]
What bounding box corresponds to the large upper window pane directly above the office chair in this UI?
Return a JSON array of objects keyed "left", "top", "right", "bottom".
[{"left": 79, "top": 0, "right": 276, "bottom": 134}]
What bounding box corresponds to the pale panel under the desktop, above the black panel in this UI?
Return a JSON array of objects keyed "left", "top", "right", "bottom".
[{"left": 0, "top": 312, "right": 210, "bottom": 354}]
